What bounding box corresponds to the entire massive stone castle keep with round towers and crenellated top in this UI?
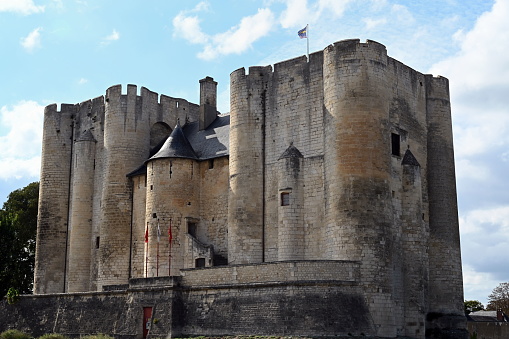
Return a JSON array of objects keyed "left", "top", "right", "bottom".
[{"left": 27, "top": 40, "right": 466, "bottom": 338}]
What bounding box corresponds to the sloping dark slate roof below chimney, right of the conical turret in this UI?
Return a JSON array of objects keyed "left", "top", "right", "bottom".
[{"left": 183, "top": 114, "right": 230, "bottom": 160}]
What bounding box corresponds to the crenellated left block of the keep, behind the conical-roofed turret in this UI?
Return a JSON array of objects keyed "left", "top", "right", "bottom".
[{"left": 35, "top": 85, "right": 199, "bottom": 293}]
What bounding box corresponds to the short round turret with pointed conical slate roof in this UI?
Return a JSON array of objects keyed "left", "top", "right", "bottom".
[{"left": 145, "top": 123, "right": 200, "bottom": 277}]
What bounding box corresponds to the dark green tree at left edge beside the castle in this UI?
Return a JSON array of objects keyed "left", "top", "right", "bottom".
[{"left": 0, "top": 182, "right": 39, "bottom": 296}]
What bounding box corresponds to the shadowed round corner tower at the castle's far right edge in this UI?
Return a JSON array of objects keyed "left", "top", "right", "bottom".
[{"left": 426, "top": 75, "right": 466, "bottom": 338}]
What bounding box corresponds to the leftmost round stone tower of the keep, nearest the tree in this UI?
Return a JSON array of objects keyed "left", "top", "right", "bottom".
[{"left": 34, "top": 104, "right": 76, "bottom": 294}]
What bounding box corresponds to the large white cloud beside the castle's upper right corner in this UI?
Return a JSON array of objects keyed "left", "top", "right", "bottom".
[{"left": 430, "top": 0, "right": 509, "bottom": 157}]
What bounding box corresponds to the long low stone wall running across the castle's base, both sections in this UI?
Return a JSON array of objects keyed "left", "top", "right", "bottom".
[{"left": 0, "top": 261, "right": 376, "bottom": 339}]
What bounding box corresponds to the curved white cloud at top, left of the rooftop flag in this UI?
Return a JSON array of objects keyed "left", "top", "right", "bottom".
[{"left": 173, "top": 3, "right": 274, "bottom": 60}]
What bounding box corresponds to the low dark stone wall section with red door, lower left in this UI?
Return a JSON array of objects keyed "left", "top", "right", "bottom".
[{"left": 0, "top": 278, "right": 179, "bottom": 339}]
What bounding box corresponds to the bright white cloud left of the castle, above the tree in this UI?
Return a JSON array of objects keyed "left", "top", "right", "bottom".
[{"left": 0, "top": 101, "right": 44, "bottom": 179}]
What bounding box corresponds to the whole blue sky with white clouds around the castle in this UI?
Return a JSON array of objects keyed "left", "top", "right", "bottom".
[{"left": 0, "top": 0, "right": 509, "bottom": 304}]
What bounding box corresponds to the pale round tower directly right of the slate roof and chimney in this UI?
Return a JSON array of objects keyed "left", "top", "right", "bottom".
[{"left": 228, "top": 67, "right": 271, "bottom": 264}]
